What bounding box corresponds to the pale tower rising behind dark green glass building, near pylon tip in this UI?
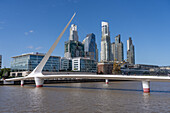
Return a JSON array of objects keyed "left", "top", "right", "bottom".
[{"left": 69, "top": 24, "right": 78, "bottom": 41}]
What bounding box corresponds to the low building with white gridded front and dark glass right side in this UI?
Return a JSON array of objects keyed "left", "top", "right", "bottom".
[{"left": 72, "top": 57, "right": 97, "bottom": 73}]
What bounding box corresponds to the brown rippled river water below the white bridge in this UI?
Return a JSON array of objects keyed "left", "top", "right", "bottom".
[{"left": 0, "top": 81, "right": 170, "bottom": 113}]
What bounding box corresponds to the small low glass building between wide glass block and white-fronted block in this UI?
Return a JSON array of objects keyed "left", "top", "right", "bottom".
[{"left": 60, "top": 57, "right": 72, "bottom": 71}]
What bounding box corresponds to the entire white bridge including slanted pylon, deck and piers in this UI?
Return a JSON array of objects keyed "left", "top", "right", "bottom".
[{"left": 4, "top": 13, "right": 170, "bottom": 93}]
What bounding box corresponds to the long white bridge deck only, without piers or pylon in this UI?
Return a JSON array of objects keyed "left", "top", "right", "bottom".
[{"left": 6, "top": 74, "right": 170, "bottom": 82}]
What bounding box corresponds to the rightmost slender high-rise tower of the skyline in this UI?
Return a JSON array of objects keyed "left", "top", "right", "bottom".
[{"left": 127, "top": 37, "right": 135, "bottom": 64}]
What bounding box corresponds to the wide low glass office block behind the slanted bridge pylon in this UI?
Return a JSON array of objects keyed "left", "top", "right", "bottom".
[{"left": 10, "top": 53, "right": 60, "bottom": 77}]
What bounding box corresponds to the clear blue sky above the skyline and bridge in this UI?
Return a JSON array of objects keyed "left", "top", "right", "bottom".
[{"left": 0, "top": 0, "right": 170, "bottom": 67}]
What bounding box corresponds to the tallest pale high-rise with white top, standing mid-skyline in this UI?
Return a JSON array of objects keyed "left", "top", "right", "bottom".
[{"left": 100, "top": 22, "right": 110, "bottom": 61}]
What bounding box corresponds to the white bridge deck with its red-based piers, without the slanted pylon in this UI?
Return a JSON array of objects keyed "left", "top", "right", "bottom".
[{"left": 5, "top": 74, "right": 170, "bottom": 93}]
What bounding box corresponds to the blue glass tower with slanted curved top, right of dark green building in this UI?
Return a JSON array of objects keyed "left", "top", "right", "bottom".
[{"left": 83, "top": 33, "right": 97, "bottom": 61}]
